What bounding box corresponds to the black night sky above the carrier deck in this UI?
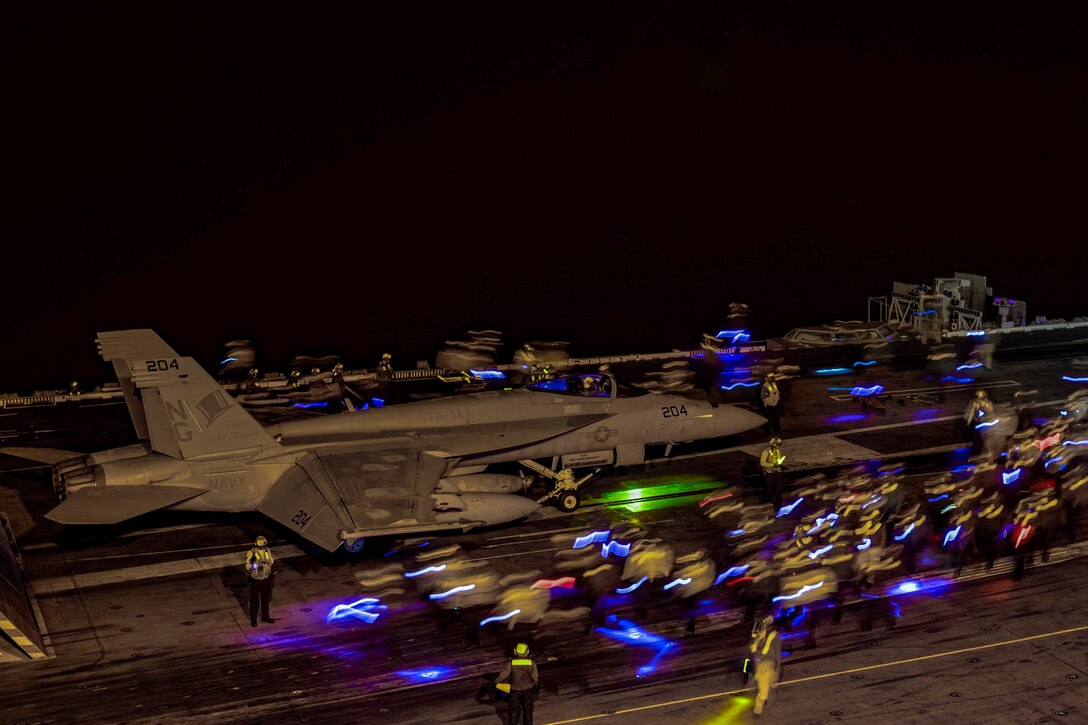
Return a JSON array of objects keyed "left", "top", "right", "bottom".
[{"left": 0, "top": 2, "right": 1088, "bottom": 391}]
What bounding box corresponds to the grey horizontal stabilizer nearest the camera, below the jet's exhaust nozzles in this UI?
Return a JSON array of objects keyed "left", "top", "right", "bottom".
[{"left": 46, "top": 486, "right": 208, "bottom": 525}]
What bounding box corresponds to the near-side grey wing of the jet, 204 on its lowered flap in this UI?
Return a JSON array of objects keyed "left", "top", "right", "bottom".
[{"left": 257, "top": 441, "right": 449, "bottom": 551}]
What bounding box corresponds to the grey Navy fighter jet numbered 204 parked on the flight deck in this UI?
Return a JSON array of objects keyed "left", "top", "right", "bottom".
[{"left": 38, "top": 330, "right": 765, "bottom": 551}]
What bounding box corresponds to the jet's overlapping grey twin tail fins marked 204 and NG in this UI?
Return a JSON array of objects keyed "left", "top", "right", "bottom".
[{"left": 98, "top": 330, "right": 277, "bottom": 459}]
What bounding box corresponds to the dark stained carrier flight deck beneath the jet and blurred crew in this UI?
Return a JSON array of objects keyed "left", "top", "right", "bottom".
[{"left": 0, "top": 350, "right": 1088, "bottom": 723}]
